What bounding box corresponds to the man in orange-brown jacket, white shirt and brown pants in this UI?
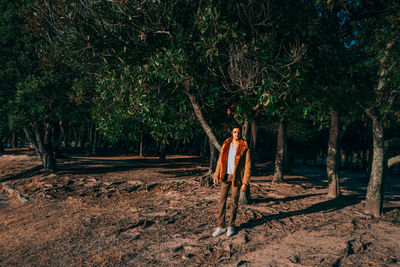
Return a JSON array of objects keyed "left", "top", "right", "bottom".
[{"left": 212, "top": 127, "right": 251, "bottom": 237}]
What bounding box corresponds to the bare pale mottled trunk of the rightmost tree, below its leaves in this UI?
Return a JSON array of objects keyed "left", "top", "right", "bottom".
[{"left": 365, "top": 115, "right": 385, "bottom": 217}]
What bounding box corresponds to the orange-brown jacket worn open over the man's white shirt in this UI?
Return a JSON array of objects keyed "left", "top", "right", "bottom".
[{"left": 214, "top": 137, "right": 251, "bottom": 186}]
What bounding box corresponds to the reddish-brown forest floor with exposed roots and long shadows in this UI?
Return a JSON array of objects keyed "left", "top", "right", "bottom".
[{"left": 0, "top": 150, "right": 400, "bottom": 266}]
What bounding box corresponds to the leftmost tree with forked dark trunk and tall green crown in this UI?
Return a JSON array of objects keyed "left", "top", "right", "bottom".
[{"left": 3, "top": 1, "right": 80, "bottom": 172}]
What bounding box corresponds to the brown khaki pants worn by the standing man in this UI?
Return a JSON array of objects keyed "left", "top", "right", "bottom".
[{"left": 217, "top": 174, "right": 240, "bottom": 228}]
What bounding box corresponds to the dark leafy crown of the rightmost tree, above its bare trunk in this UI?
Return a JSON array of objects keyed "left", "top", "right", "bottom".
[{"left": 352, "top": 1, "right": 400, "bottom": 116}]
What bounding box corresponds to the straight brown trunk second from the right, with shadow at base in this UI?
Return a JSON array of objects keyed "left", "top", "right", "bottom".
[{"left": 326, "top": 109, "right": 340, "bottom": 198}]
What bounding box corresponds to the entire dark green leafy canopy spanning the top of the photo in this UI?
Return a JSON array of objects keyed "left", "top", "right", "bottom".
[{"left": 0, "top": 0, "right": 400, "bottom": 163}]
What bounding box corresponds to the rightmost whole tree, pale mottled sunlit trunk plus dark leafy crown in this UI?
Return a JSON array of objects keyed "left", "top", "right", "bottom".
[{"left": 353, "top": 1, "right": 400, "bottom": 217}]
